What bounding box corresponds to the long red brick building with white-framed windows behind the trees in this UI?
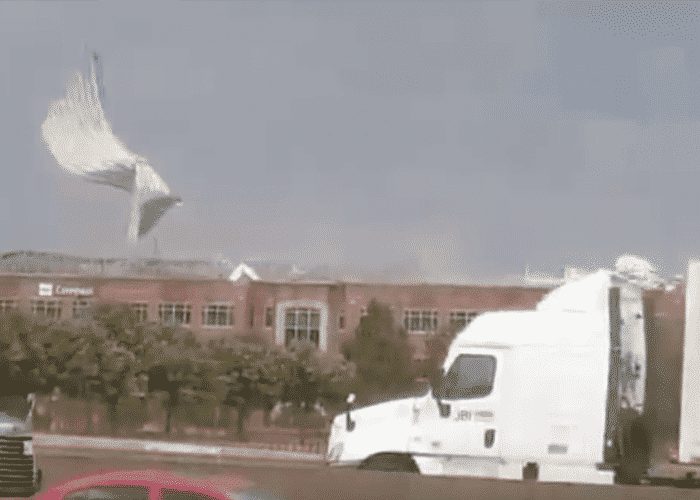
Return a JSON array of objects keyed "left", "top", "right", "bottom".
[{"left": 0, "top": 252, "right": 548, "bottom": 352}]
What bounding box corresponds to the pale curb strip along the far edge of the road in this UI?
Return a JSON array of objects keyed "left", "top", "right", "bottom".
[{"left": 33, "top": 433, "right": 324, "bottom": 462}]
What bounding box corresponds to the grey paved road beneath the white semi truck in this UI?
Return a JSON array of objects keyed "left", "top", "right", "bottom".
[{"left": 37, "top": 450, "right": 700, "bottom": 500}]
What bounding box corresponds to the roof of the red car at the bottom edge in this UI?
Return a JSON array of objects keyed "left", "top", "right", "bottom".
[{"left": 36, "top": 470, "right": 281, "bottom": 500}]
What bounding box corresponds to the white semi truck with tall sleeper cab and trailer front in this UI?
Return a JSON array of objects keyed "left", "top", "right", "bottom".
[{"left": 327, "top": 263, "right": 700, "bottom": 484}]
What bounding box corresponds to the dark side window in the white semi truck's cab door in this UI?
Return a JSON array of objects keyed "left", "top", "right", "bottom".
[{"left": 442, "top": 354, "right": 496, "bottom": 399}]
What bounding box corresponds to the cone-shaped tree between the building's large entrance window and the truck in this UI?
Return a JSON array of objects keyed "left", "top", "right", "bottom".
[{"left": 343, "top": 300, "right": 415, "bottom": 399}]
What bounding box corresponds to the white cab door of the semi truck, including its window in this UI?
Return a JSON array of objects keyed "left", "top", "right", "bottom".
[{"left": 433, "top": 351, "right": 502, "bottom": 470}]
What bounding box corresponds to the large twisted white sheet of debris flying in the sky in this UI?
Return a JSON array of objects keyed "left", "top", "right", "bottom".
[{"left": 41, "top": 53, "right": 182, "bottom": 242}]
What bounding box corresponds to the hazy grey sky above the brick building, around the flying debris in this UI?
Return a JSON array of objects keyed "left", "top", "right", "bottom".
[{"left": 0, "top": 0, "right": 700, "bottom": 280}]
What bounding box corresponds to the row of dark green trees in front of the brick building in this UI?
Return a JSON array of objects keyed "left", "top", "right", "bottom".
[{"left": 0, "top": 302, "right": 450, "bottom": 439}]
